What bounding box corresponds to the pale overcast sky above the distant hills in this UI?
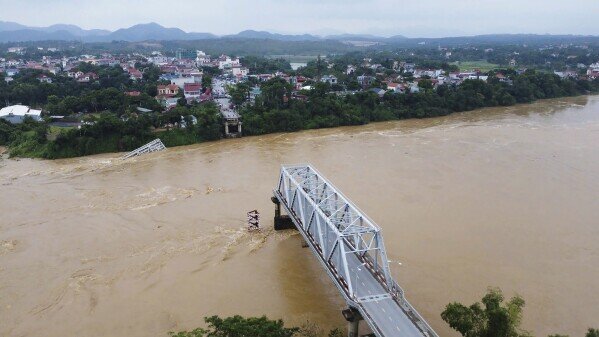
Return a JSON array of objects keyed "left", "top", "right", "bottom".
[{"left": 0, "top": 0, "right": 599, "bottom": 37}]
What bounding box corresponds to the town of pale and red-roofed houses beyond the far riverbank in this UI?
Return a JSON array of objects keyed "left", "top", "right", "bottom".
[{"left": 0, "top": 47, "right": 599, "bottom": 136}]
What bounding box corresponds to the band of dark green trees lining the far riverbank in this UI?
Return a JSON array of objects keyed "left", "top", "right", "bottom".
[{"left": 0, "top": 60, "right": 599, "bottom": 159}]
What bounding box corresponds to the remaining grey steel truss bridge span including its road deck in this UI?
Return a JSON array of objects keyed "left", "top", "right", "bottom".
[{"left": 273, "top": 164, "right": 438, "bottom": 337}]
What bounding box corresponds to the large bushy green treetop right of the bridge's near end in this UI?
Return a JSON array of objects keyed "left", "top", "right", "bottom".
[{"left": 441, "top": 289, "right": 530, "bottom": 337}]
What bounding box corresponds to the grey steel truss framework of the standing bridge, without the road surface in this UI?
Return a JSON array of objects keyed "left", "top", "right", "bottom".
[{"left": 274, "top": 164, "right": 438, "bottom": 337}]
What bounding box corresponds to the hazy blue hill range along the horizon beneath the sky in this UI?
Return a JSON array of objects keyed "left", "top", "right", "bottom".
[{"left": 0, "top": 21, "right": 599, "bottom": 48}]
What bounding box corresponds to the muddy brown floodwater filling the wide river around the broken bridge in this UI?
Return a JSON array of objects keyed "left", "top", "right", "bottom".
[{"left": 0, "top": 96, "right": 599, "bottom": 337}]
